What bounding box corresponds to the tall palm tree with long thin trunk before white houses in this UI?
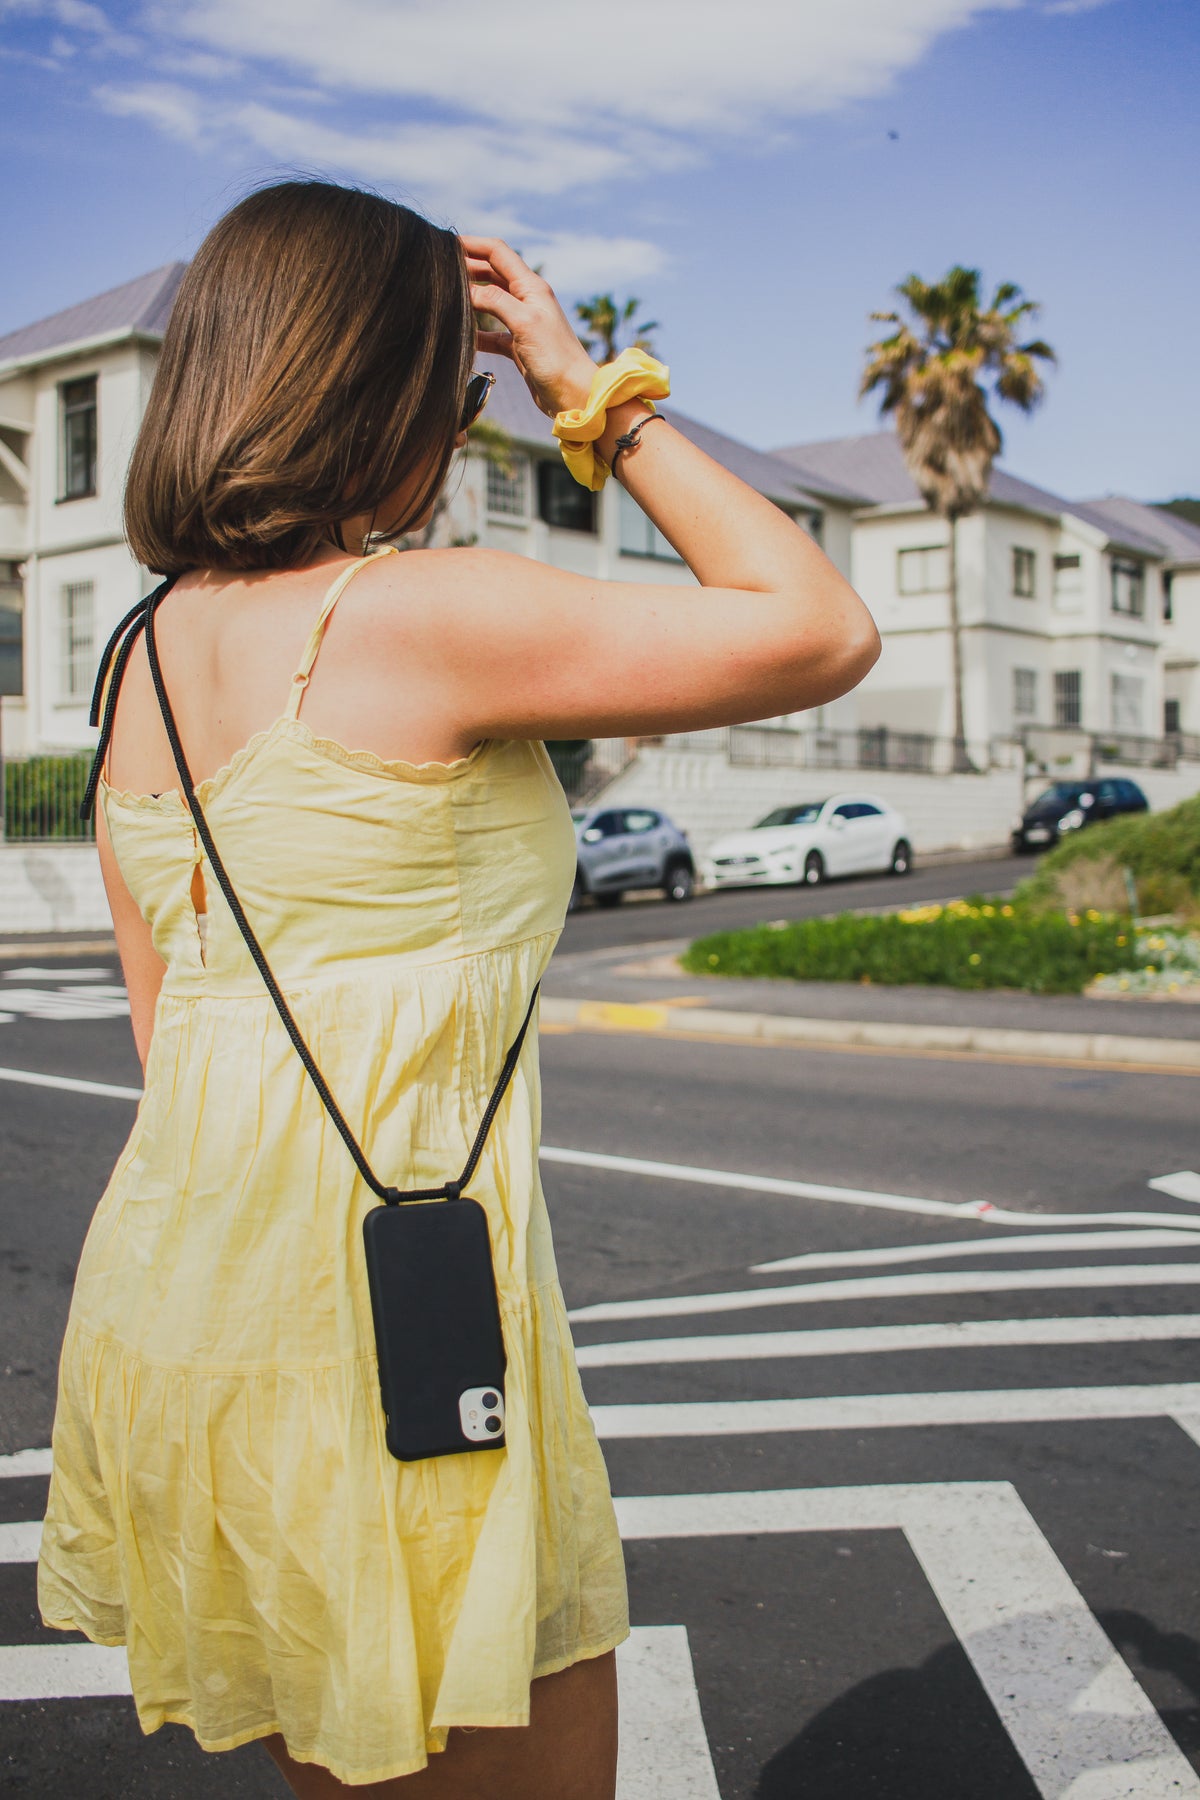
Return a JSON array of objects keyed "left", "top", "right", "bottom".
[{"left": 858, "top": 263, "right": 1056, "bottom": 770}]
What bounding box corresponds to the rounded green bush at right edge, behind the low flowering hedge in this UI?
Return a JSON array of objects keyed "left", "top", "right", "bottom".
[{"left": 1016, "top": 794, "right": 1200, "bottom": 918}]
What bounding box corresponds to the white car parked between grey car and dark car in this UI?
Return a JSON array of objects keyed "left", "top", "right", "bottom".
[{"left": 703, "top": 794, "right": 912, "bottom": 887}]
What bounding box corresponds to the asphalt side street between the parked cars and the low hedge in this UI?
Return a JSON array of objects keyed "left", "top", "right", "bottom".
[{"left": 561, "top": 857, "right": 1036, "bottom": 952}]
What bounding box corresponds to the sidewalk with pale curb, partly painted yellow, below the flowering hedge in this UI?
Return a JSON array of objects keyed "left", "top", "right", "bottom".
[{"left": 542, "top": 938, "right": 1200, "bottom": 1075}]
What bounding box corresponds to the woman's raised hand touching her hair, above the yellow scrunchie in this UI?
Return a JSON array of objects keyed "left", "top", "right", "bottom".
[{"left": 462, "top": 238, "right": 596, "bottom": 418}]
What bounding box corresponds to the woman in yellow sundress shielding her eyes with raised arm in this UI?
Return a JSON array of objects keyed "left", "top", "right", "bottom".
[{"left": 40, "top": 182, "right": 878, "bottom": 1800}]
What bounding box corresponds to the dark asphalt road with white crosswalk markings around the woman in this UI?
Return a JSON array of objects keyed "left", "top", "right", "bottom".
[{"left": 0, "top": 950, "right": 1200, "bottom": 1800}]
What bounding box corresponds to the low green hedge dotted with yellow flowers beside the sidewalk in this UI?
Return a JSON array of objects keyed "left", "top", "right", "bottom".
[{"left": 682, "top": 896, "right": 1144, "bottom": 994}]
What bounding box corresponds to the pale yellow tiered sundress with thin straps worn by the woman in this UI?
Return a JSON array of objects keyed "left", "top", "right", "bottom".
[{"left": 38, "top": 558, "right": 628, "bottom": 1784}]
